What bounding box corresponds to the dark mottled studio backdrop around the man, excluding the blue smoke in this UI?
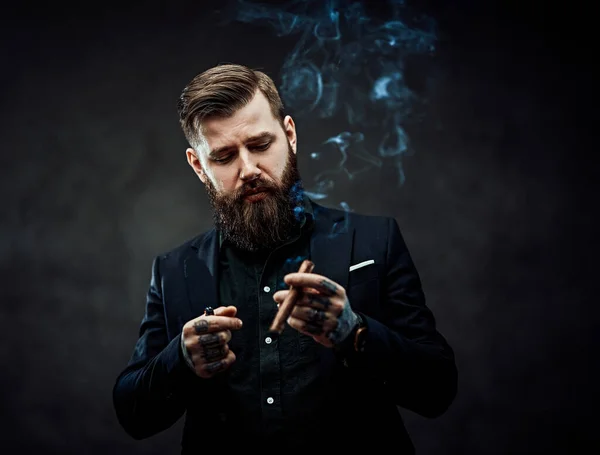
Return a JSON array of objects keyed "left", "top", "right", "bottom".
[{"left": 0, "top": 1, "right": 600, "bottom": 455}]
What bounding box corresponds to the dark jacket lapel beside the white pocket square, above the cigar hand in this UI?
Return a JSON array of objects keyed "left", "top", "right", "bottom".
[{"left": 310, "top": 202, "right": 354, "bottom": 289}]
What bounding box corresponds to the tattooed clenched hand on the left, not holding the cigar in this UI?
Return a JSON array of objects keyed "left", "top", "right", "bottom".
[{"left": 181, "top": 306, "right": 242, "bottom": 378}]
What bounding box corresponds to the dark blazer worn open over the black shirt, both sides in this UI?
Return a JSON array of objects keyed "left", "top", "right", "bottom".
[{"left": 113, "top": 201, "right": 457, "bottom": 453}]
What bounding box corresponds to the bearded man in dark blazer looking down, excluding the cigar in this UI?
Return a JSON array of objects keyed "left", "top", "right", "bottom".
[{"left": 113, "top": 65, "right": 457, "bottom": 454}]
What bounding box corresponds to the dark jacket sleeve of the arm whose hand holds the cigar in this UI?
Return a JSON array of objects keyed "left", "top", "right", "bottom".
[{"left": 352, "top": 218, "right": 458, "bottom": 417}]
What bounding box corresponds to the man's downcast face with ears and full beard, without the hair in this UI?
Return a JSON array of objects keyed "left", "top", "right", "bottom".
[{"left": 186, "top": 92, "right": 301, "bottom": 252}]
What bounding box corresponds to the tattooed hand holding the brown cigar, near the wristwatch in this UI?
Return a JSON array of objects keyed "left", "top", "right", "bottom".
[{"left": 273, "top": 272, "right": 358, "bottom": 347}]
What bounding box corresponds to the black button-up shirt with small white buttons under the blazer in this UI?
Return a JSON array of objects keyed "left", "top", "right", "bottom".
[{"left": 219, "top": 198, "right": 336, "bottom": 440}]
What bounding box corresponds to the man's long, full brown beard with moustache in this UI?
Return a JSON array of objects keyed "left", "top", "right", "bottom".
[{"left": 206, "top": 144, "right": 304, "bottom": 253}]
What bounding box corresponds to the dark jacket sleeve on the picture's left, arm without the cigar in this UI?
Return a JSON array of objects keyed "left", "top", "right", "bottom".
[{"left": 113, "top": 257, "right": 195, "bottom": 439}]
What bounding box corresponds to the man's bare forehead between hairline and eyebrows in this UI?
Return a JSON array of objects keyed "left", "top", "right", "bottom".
[{"left": 202, "top": 91, "right": 280, "bottom": 150}]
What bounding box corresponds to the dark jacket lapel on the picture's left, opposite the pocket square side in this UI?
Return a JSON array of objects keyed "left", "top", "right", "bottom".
[{"left": 183, "top": 229, "right": 219, "bottom": 317}]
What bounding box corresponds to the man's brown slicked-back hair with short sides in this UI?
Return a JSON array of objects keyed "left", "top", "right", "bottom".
[{"left": 177, "top": 64, "right": 284, "bottom": 148}]
